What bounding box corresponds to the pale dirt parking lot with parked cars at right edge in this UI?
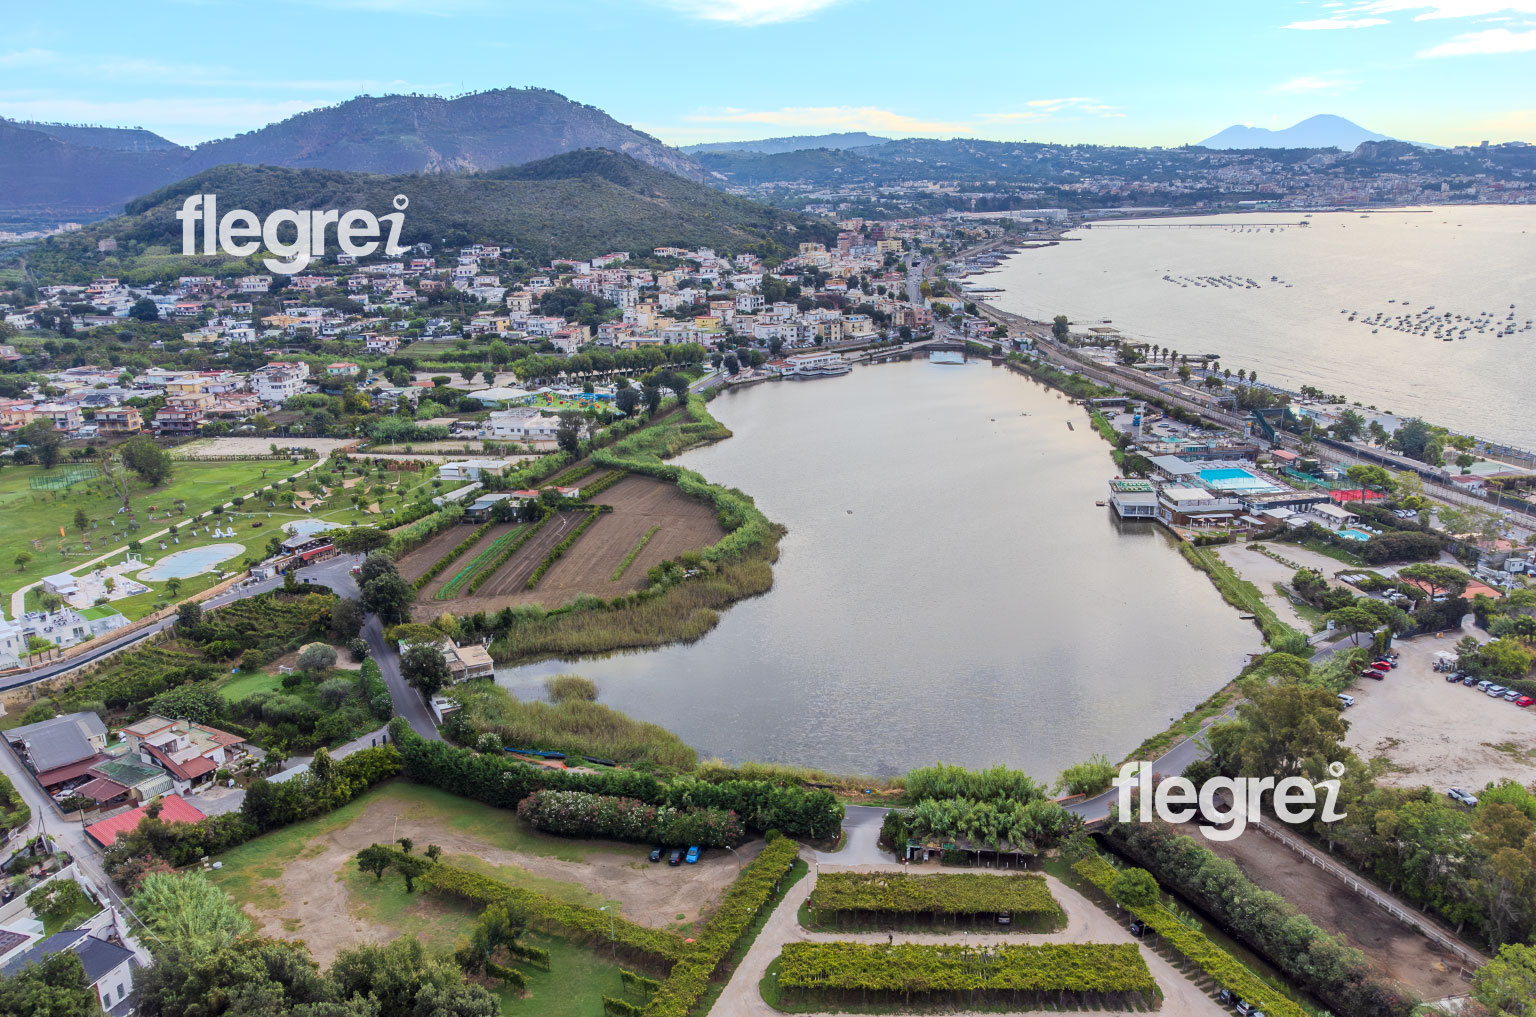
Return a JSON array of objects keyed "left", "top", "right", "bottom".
[{"left": 1344, "top": 625, "right": 1536, "bottom": 793}]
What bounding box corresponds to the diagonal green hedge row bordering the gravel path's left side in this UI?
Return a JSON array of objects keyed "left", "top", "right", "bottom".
[{"left": 642, "top": 837, "right": 800, "bottom": 1017}]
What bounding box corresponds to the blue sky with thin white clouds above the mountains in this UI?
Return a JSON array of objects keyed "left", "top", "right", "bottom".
[{"left": 0, "top": 0, "right": 1536, "bottom": 144}]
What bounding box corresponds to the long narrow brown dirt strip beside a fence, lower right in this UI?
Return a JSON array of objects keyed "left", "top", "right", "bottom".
[{"left": 1183, "top": 823, "right": 1467, "bottom": 1000}]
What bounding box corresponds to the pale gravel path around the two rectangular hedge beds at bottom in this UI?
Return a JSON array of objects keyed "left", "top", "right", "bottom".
[{"left": 710, "top": 859, "right": 1227, "bottom": 1017}]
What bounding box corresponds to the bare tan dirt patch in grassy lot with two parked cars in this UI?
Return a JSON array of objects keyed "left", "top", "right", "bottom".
[{"left": 236, "top": 800, "right": 762, "bottom": 966}]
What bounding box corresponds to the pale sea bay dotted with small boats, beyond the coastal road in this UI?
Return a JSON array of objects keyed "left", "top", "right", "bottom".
[{"left": 966, "top": 206, "right": 1536, "bottom": 449}]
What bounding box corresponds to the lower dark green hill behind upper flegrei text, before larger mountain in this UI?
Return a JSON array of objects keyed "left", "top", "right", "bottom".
[{"left": 14, "top": 149, "right": 828, "bottom": 283}]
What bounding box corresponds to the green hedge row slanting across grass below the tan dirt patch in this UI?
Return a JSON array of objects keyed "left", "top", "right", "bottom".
[{"left": 421, "top": 862, "right": 688, "bottom": 963}]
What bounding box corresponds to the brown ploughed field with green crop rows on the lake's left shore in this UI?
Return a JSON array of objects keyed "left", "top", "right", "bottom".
[{"left": 444, "top": 476, "right": 725, "bottom": 615}]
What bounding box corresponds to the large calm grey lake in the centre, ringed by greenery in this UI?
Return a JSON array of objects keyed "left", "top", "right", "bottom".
[{"left": 498, "top": 363, "right": 1260, "bottom": 779}]
